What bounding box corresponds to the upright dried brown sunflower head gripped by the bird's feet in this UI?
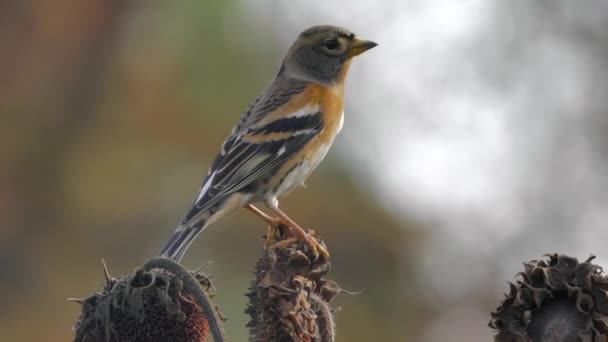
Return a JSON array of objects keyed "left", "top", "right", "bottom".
[{"left": 245, "top": 226, "right": 341, "bottom": 342}]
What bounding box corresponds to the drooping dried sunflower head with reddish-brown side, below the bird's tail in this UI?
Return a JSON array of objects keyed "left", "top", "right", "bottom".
[{"left": 74, "top": 260, "right": 222, "bottom": 342}]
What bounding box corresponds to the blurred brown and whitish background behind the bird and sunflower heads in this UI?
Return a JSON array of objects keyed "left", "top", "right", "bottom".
[{"left": 0, "top": 0, "right": 608, "bottom": 341}]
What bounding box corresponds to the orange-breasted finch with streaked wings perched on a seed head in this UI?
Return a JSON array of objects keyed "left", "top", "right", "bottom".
[{"left": 160, "top": 25, "right": 378, "bottom": 262}]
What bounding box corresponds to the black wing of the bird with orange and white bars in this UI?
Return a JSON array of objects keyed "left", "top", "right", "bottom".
[{"left": 181, "top": 81, "right": 323, "bottom": 227}]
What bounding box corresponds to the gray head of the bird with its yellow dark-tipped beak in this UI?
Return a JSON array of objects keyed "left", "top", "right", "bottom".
[{"left": 279, "top": 25, "right": 378, "bottom": 84}]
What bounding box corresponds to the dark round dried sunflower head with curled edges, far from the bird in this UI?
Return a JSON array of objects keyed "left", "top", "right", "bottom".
[{"left": 489, "top": 254, "right": 608, "bottom": 342}]
